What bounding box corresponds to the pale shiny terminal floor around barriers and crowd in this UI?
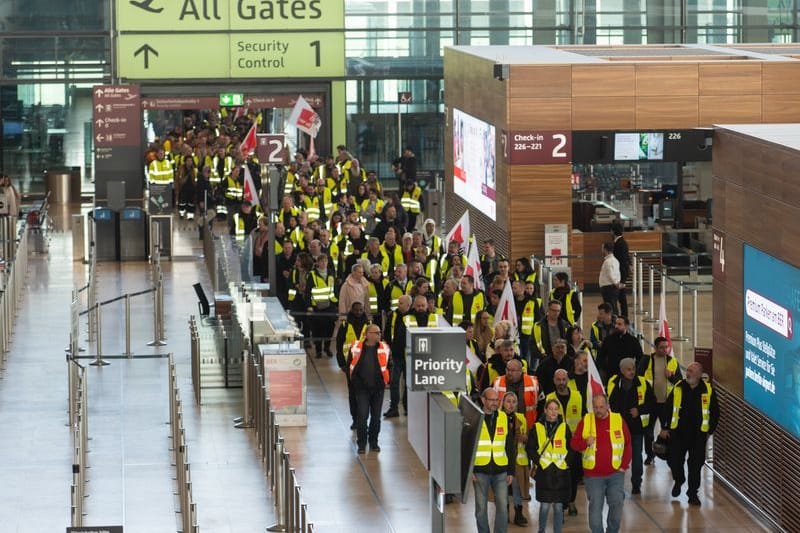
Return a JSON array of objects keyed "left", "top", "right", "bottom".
[{"left": 0, "top": 205, "right": 768, "bottom": 533}]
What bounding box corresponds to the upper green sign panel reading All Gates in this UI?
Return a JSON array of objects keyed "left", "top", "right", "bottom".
[{"left": 116, "top": 0, "right": 344, "bottom": 33}]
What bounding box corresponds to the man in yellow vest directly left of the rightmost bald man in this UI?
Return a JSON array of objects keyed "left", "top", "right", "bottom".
[{"left": 637, "top": 337, "right": 683, "bottom": 465}]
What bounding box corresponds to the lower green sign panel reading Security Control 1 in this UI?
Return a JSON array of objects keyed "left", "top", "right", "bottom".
[{"left": 117, "top": 32, "right": 345, "bottom": 78}]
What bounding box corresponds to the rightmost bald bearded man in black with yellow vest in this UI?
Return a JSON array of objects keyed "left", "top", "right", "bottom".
[{"left": 661, "top": 363, "right": 719, "bottom": 506}]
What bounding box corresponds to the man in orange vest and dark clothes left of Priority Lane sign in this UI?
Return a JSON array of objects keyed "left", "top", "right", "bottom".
[{"left": 349, "top": 324, "right": 390, "bottom": 454}]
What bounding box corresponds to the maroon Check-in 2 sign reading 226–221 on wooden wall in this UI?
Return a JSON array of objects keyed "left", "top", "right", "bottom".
[{"left": 504, "top": 131, "right": 572, "bottom": 165}]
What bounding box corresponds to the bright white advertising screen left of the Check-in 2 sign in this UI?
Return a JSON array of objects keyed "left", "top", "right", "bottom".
[{"left": 453, "top": 108, "right": 497, "bottom": 220}]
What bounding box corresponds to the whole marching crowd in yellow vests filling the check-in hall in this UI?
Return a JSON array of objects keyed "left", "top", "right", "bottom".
[{"left": 142, "top": 115, "right": 719, "bottom": 533}]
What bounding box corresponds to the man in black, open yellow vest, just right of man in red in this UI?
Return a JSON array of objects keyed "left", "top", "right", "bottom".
[{"left": 608, "top": 357, "right": 655, "bottom": 494}]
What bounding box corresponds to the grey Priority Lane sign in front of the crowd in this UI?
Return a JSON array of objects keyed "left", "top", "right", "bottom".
[{"left": 406, "top": 327, "right": 467, "bottom": 392}]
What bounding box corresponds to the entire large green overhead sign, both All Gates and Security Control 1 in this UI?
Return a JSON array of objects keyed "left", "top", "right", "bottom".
[{"left": 117, "top": 0, "right": 345, "bottom": 79}]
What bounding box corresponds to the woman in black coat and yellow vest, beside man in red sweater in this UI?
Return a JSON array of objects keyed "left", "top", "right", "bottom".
[{"left": 525, "top": 399, "right": 573, "bottom": 533}]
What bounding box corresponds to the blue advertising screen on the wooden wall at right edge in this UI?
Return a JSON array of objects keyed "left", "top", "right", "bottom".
[{"left": 743, "top": 244, "right": 800, "bottom": 437}]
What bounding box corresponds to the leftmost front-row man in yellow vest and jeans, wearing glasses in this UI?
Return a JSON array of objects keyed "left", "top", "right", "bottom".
[{"left": 472, "top": 387, "right": 517, "bottom": 533}]
